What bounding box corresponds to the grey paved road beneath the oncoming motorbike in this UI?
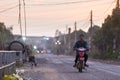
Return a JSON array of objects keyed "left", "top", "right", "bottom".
[{"left": 22, "top": 54, "right": 120, "bottom": 80}]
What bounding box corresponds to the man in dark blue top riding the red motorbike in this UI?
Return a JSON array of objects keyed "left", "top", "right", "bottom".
[{"left": 73, "top": 34, "right": 89, "bottom": 67}]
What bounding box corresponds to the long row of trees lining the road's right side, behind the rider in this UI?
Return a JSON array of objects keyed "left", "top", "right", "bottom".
[{"left": 52, "top": 8, "right": 120, "bottom": 59}]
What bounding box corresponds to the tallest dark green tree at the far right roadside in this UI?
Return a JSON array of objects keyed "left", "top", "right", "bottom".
[{"left": 93, "top": 8, "right": 120, "bottom": 59}]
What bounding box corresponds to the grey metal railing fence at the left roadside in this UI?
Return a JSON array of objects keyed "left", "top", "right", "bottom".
[{"left": 0, "top": 51, "right": 25, "bottom": 80}]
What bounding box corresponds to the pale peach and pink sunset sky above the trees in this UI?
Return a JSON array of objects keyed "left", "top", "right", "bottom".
[{"left": 0, "top": 0, "right": 116, "bottom": 36}]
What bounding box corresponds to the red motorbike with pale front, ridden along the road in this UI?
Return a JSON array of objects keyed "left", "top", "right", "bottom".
[{"left": 76, "top": 48, "right": 86, "bottom": 72}]
